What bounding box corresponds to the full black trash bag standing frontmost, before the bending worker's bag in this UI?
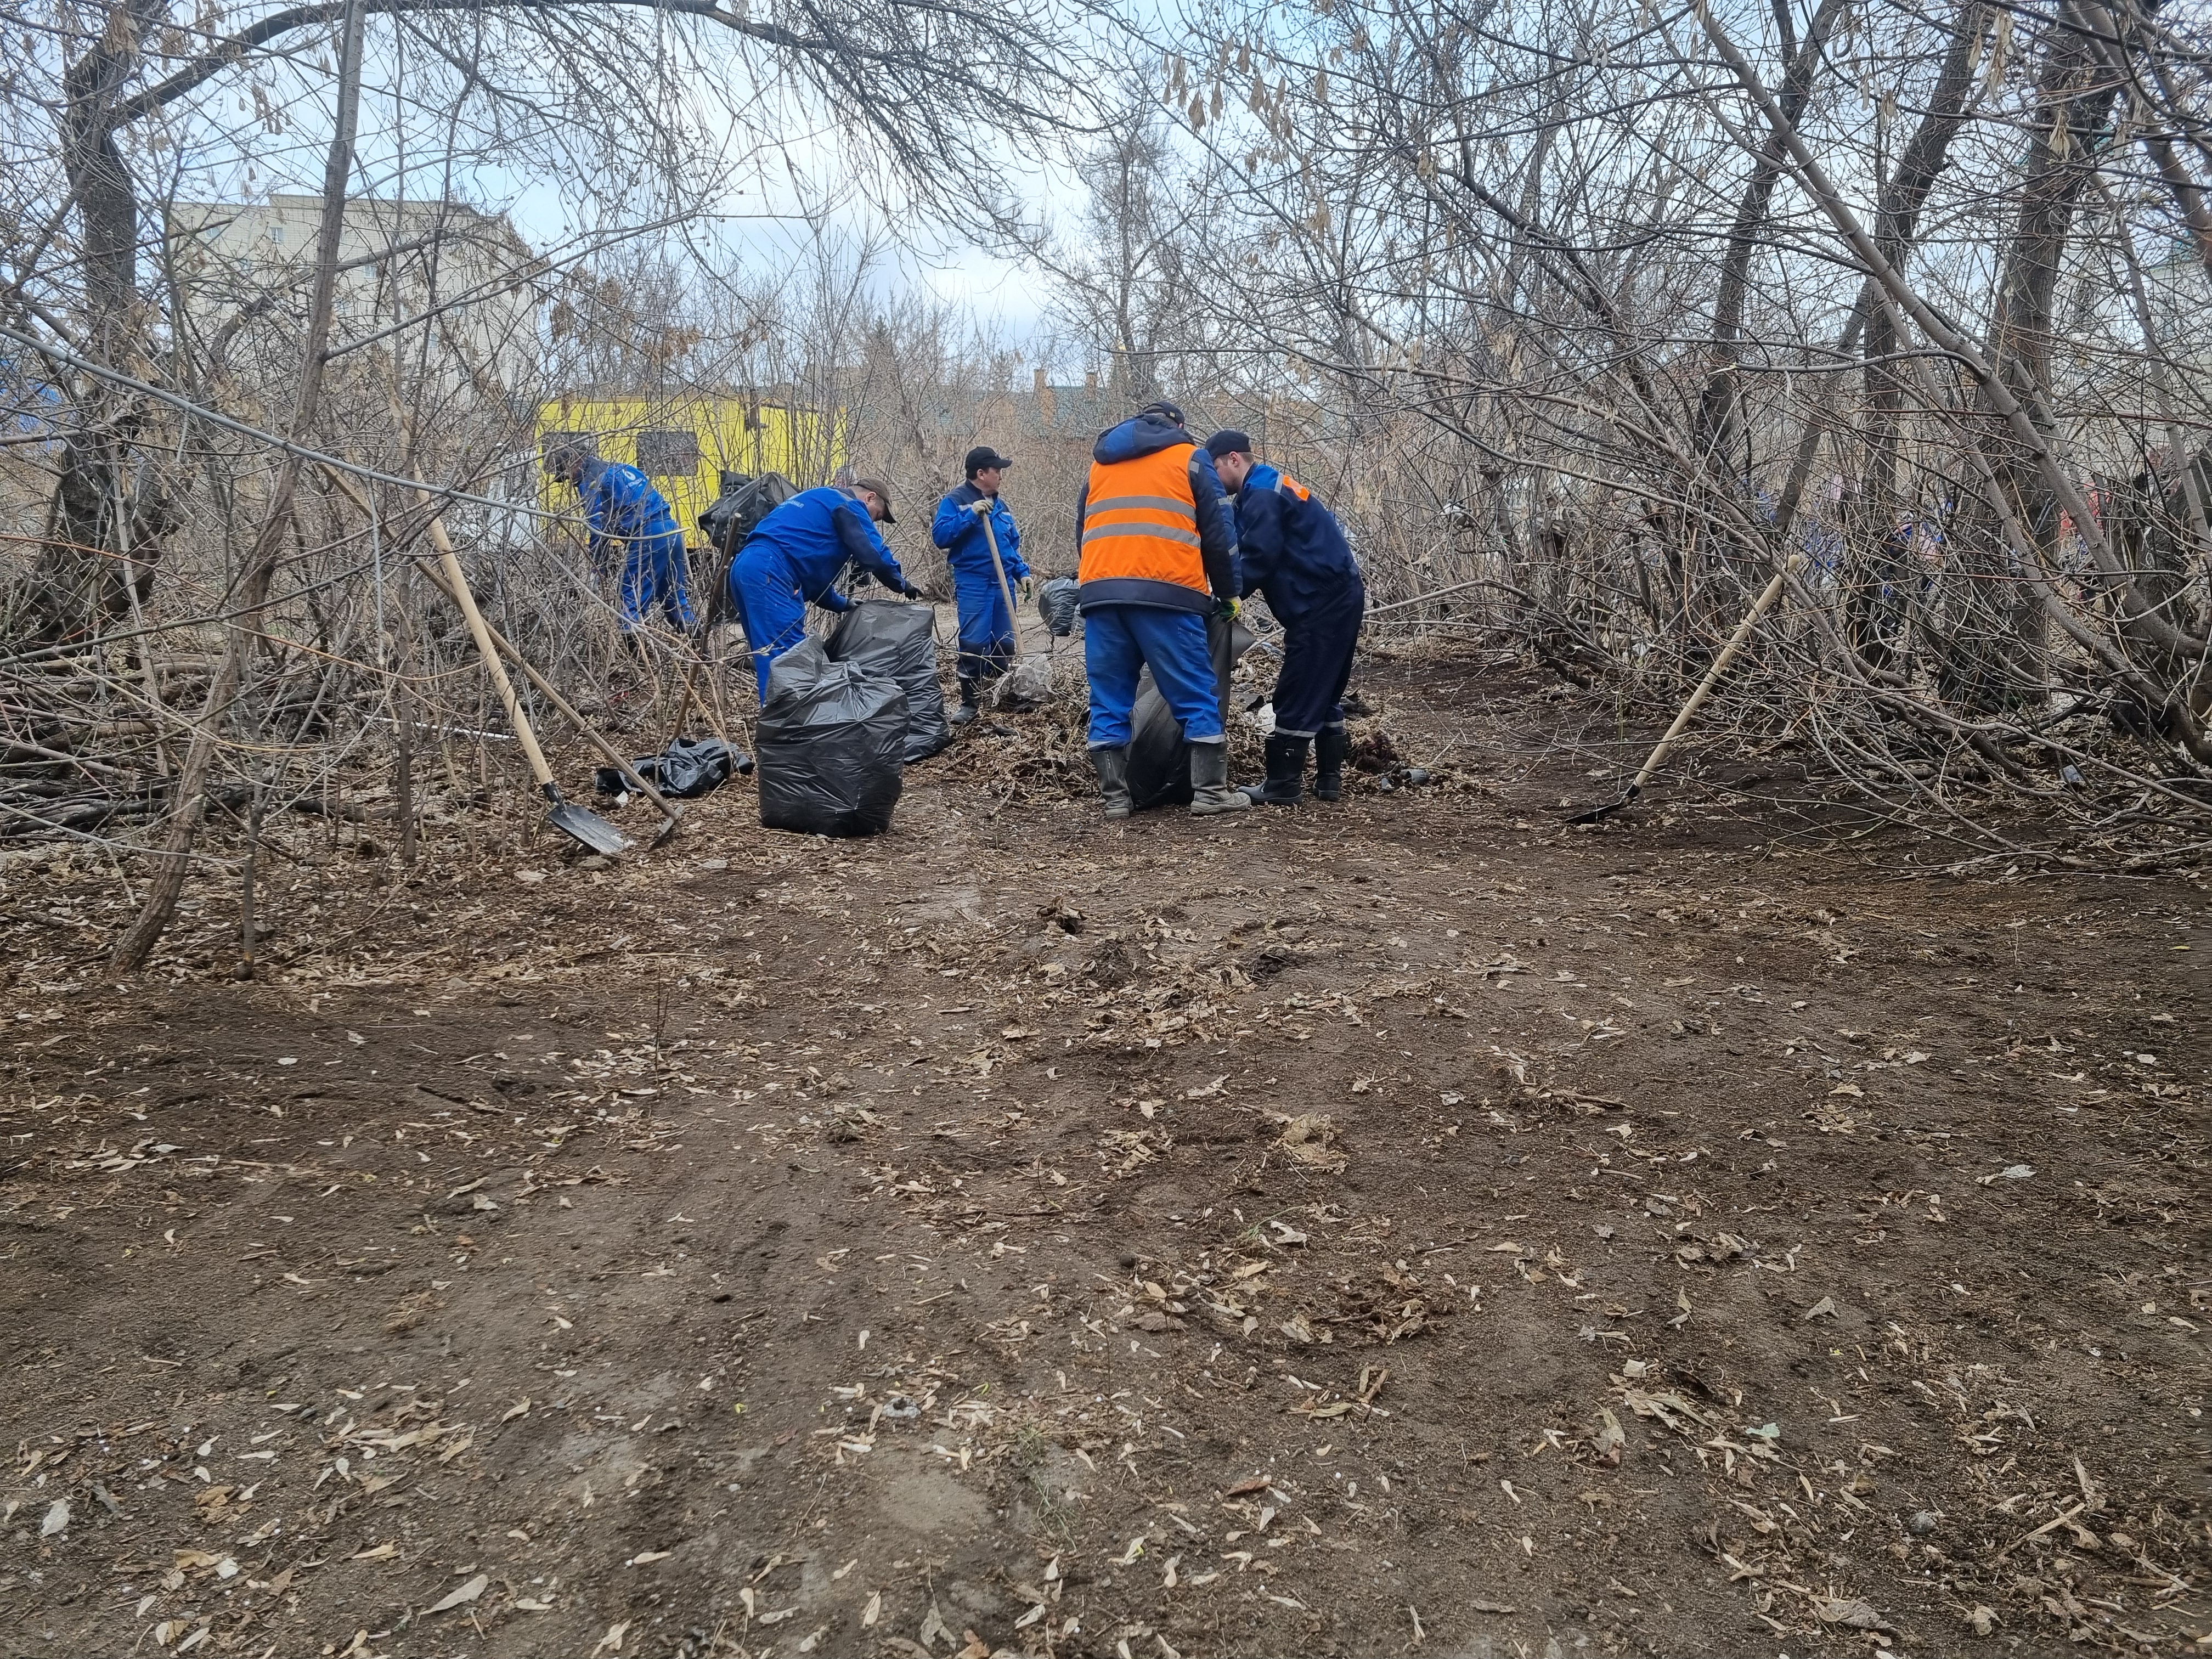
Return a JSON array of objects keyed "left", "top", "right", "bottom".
[{"left": 759, "top": 639, "right": 907, "bottom": 836}]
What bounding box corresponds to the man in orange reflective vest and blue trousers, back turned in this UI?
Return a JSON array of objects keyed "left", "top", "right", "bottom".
[{"left": 1075, "top": 403, "right": 1252, "bottom": 819}]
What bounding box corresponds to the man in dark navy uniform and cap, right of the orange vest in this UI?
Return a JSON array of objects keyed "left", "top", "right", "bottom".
[{"left": 1205, "top": 429, "right": 1367, "bottom": 808}]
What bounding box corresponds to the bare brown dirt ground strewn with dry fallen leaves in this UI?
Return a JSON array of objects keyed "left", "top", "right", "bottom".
[{"left": 0, "top": 657, "right": 2212, "bottom": 1659}]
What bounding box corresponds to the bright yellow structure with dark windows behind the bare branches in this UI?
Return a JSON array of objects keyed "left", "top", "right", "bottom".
[{"left": 538, "top": 394, "right": 845, "bottom": 546}]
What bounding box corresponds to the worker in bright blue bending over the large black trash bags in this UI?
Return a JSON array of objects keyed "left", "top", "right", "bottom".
[{"left": 730, "top": 478, "right": 922, "bottom": 703}]
